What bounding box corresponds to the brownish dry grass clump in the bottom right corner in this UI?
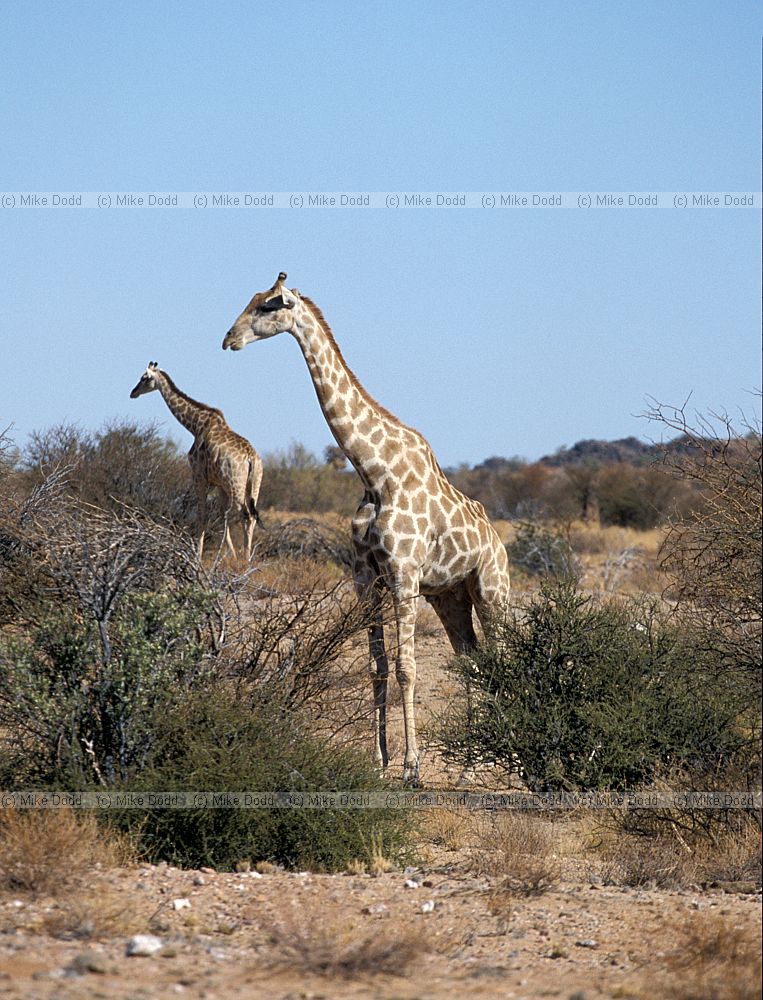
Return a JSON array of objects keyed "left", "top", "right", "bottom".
[{"left": 662, "top": 913, "right": 761, "bottom": 1000}]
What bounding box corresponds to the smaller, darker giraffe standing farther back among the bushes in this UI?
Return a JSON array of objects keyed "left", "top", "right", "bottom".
[{"left": 130, "top": 361, "right": 262, "bottom": 559}]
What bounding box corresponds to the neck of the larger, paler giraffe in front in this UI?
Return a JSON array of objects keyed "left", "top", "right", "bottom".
[{"left": 292, "top": 297, "right": 423, "bottom": 492}]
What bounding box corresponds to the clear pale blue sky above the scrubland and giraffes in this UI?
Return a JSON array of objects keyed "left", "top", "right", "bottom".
[{"left": 0, "top": 0, "right": 763, "bottom": 465}]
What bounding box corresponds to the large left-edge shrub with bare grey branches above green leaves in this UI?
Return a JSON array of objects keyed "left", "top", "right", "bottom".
[{"left": 0, "top": 498, "right": 214, "bottom": 787}]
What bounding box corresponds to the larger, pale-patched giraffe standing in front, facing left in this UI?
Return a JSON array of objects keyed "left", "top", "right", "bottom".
[{"left": 223, "top": 272, "right": 509, "bottom": 781}]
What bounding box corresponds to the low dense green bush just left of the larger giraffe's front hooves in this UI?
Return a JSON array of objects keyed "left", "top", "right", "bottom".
[{"left": 110, "top": 683, "right": 411, "bottom": 871}]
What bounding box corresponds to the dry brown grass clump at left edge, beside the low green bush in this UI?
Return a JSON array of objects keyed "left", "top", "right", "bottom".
[{"left": 0, "top": 808, "right": 135, "bottom": 897}]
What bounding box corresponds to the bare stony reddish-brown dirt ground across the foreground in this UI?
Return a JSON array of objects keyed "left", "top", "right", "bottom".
[{"left": 0, "top": 852, "right": 760, "bottom": 1000}]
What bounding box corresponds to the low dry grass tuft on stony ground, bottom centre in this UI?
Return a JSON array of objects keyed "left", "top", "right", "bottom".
[{"left": 270, "top": 910, "right": 429, "bottom": 979}]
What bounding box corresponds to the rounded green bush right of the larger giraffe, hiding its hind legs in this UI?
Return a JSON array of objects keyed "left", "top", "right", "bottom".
[{"left": 441, "top": 581, "right": 748, "bottom": 791}]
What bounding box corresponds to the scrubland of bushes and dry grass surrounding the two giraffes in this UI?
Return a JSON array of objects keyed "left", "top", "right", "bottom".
[{"left": 0, "top": 407, "right": 761, "bottom": 900}]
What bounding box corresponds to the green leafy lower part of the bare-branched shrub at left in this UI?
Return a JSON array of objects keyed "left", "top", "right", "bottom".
[{"left": 0, "top": 587, "right": 215, "bottom": 787}]
